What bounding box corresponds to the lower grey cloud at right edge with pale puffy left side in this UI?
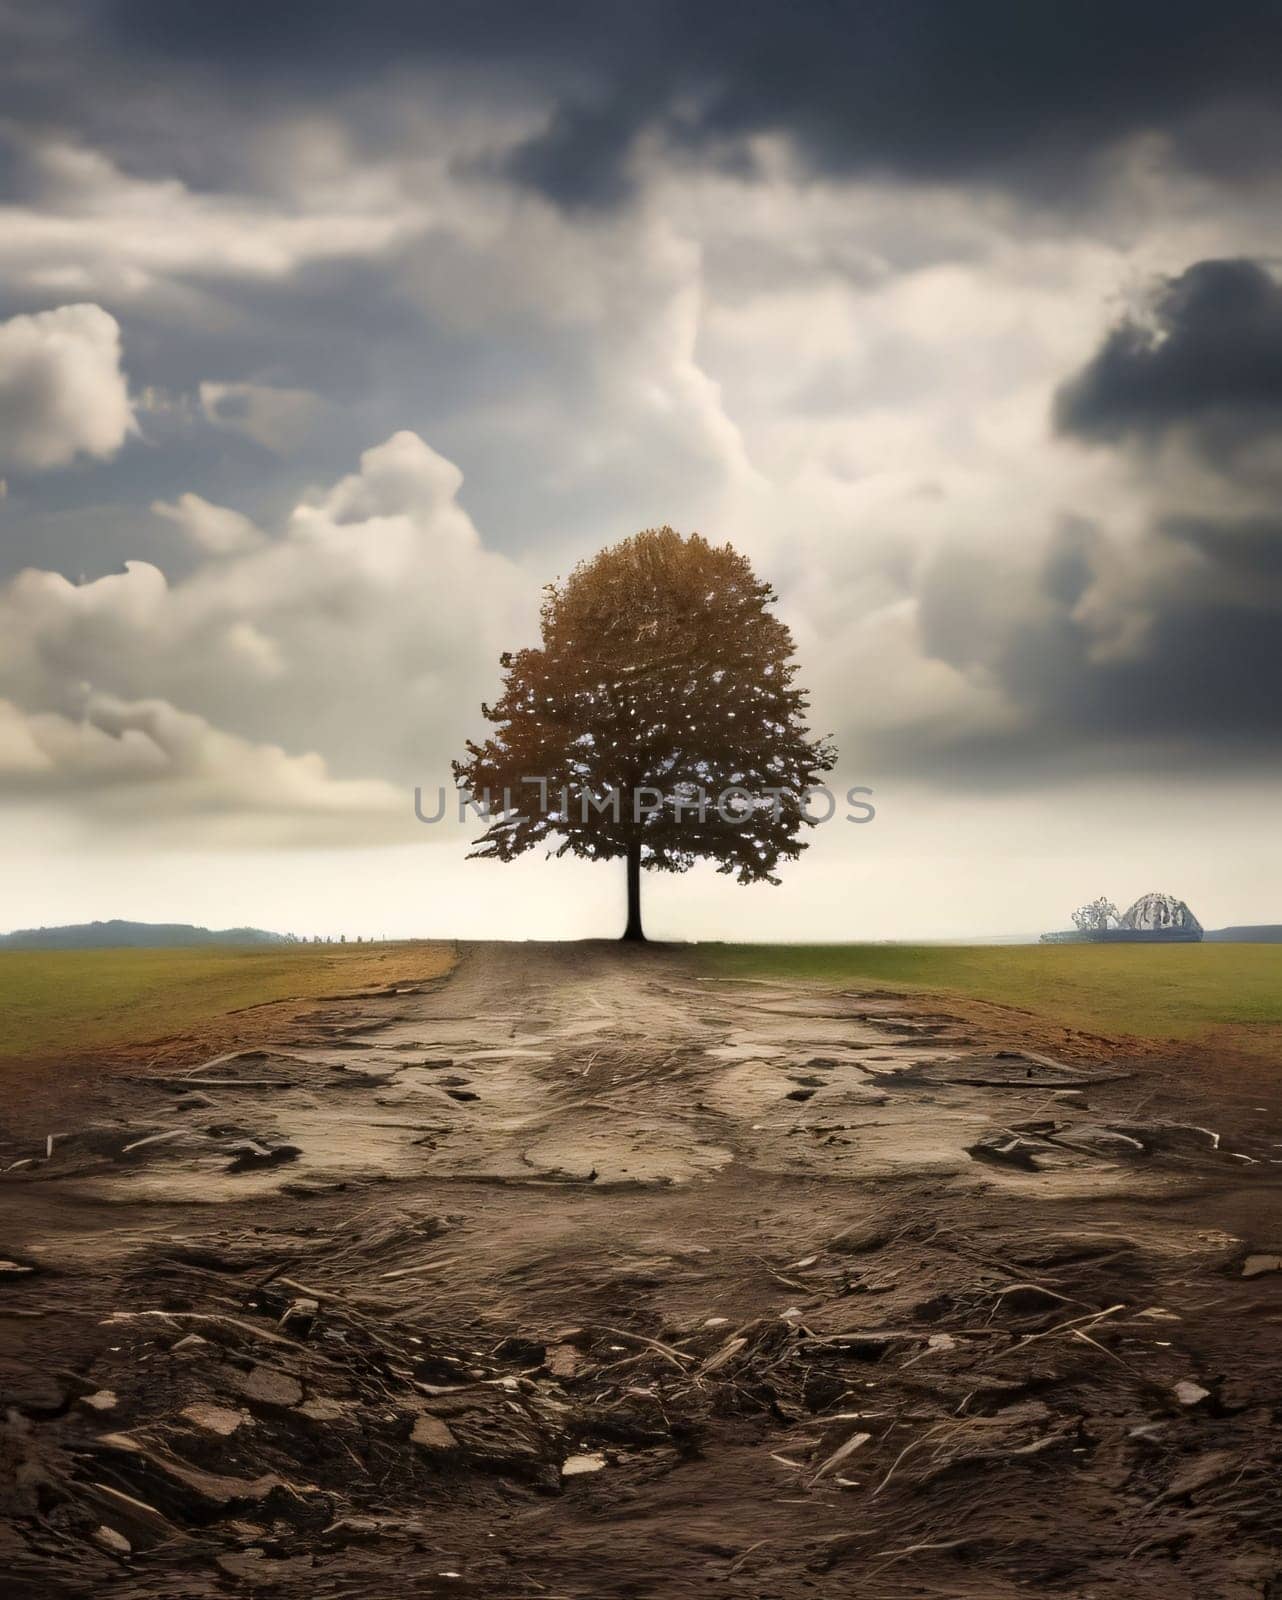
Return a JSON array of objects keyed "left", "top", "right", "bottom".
[{"left": 885, "top": 517, "right": 1282, "bottom": 782}]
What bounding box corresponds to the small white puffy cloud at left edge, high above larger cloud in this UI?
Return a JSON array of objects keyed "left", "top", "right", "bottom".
[{"left": 0, "top": 304, "right": 134, "bottom": 470}]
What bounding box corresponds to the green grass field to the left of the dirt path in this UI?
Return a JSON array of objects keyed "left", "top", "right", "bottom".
[{"left": 0, "top": 944, "right": 451, "bottom": 1061}]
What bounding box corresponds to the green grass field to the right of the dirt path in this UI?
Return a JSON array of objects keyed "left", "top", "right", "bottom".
[{"left": 703, "top": 944, "right": 1282, "bottom": 1048}]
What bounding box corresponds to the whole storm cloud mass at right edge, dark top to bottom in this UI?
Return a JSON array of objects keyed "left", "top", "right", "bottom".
[{"left": 898, "top": 258, "right": 1282, "bottom": 782}]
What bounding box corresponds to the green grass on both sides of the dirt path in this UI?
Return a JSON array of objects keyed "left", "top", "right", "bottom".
[{"left": 0, "top": 944, "right": 1282, "bottom": 1061}]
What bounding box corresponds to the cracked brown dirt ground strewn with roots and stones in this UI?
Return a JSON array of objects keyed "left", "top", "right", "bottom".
[{"left": 0, "top": 946, "right": 1282, "bottom": 1600}]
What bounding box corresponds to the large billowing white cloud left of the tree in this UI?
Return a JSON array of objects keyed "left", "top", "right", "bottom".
[{"left": 0, "top": 432, "right": 538, "bottom": 842}]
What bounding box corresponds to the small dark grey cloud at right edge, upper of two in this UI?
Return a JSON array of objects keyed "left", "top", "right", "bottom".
[{"left": 1055, "top": 259, "right": 1282, "bottom": 459}]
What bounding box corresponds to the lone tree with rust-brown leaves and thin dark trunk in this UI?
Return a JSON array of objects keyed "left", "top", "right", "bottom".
[{"left": 453, "top": 528, "right": 834, "bottom": 939}]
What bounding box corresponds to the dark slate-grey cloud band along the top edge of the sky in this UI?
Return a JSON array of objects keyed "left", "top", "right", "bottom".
[{"left": 14, "top": 0, "right": 1282, "bottom": 205}]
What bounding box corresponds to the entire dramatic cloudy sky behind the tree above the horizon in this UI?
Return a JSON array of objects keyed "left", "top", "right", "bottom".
[{"left": 0, "top": 0, "right": 1282, "bottom": 938}]
